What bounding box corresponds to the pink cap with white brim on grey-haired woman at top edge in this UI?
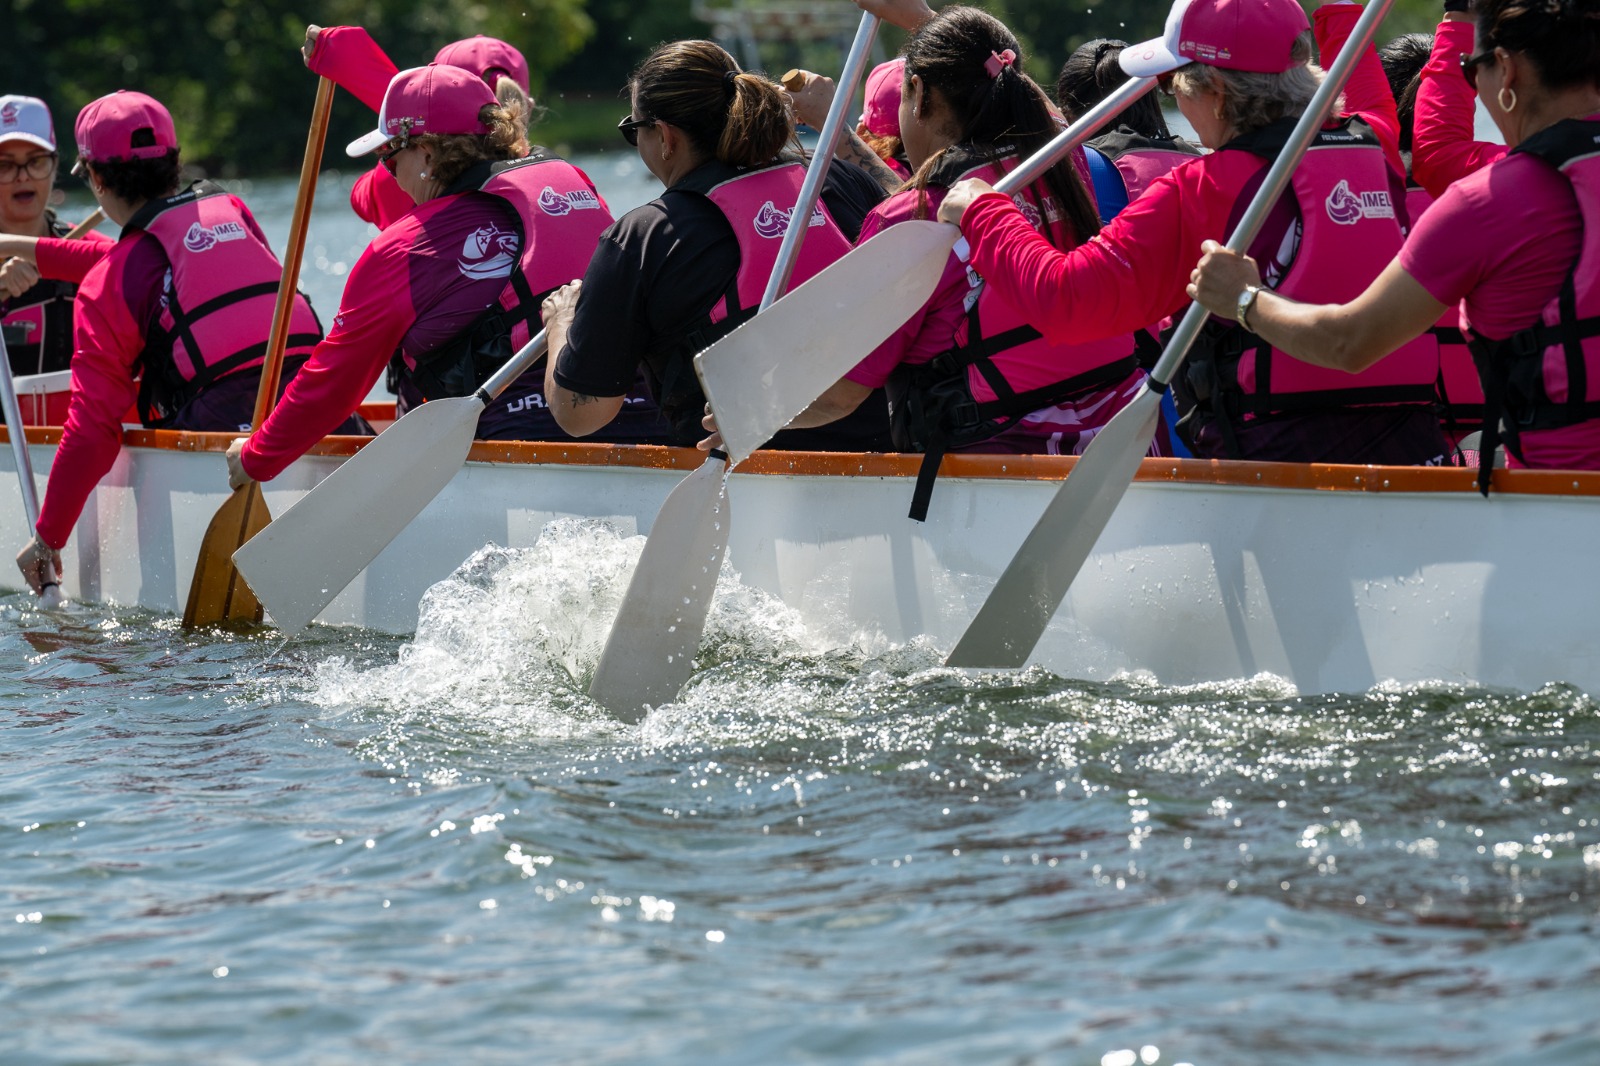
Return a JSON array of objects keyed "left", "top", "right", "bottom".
[{"left": 1122, "top": 0, "right": 1310, "bottom": 78}]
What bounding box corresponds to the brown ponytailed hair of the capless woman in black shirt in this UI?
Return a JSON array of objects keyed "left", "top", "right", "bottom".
[{"left": 629, "top": 40, "right": 798, "bottom": 166}]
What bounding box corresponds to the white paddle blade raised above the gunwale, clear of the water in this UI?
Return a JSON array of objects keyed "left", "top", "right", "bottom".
[{"left": 694, "top": 222, "right": 962, "bottom": 464}]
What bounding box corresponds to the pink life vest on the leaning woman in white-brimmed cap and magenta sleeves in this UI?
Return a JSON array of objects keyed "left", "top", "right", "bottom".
[{"left": 403, "top": 149, "right": 613, "bottom": 400}]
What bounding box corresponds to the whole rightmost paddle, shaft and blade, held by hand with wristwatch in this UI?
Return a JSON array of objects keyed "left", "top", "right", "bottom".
[{"left": 946, "top": 0, "right": 1394, "bottom": 666}]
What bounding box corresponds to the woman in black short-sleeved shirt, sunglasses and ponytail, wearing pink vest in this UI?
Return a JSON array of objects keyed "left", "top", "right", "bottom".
[{"left": 544, "top": 40, "right": 888, "bottom": 451}]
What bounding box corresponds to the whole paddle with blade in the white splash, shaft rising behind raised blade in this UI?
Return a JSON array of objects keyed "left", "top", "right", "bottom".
[{"left": 589, "top": 14, "right": 878, "bottom": 722}]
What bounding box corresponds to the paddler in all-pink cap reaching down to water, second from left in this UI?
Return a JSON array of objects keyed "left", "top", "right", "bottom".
[{"left": 18, "top": 91, "right": 322, "bottom": 592}]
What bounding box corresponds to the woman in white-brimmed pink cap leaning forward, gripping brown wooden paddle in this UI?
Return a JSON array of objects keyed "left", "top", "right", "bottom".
[{"left": 227, "top": 64, "right": 649, "bottom": 487}]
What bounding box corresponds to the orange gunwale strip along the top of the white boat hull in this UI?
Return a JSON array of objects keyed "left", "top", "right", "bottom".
[{"left": 0, "top": 426, "right": 1600, "bottom": 496}]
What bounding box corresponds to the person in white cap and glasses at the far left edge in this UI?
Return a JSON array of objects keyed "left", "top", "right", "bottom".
[{"left": 0, "top": 96, "right": 112, "bottom": 375}]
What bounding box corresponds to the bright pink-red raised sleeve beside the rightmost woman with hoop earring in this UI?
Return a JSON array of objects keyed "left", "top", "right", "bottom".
[{"left": 1411, "top": 21, "right": 1507, "bottom": 200}]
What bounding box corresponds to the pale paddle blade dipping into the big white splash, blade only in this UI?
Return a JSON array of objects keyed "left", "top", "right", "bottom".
[{"left": 589, "top": 458, "right": 731, "bottom": 722}]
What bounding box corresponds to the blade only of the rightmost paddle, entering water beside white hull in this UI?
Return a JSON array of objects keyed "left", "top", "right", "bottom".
[{"left": 944, "top": 387, "right": 1162, "bottom": 667}]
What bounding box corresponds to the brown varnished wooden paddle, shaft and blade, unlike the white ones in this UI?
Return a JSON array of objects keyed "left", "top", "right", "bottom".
[{"left": 184, "top": 78, "right": 333, "bottom": 629}]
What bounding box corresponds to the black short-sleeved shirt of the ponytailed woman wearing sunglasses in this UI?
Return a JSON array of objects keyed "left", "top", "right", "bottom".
[{"left": 555, "top": 153, "right": 888, "bottom": 451}]
